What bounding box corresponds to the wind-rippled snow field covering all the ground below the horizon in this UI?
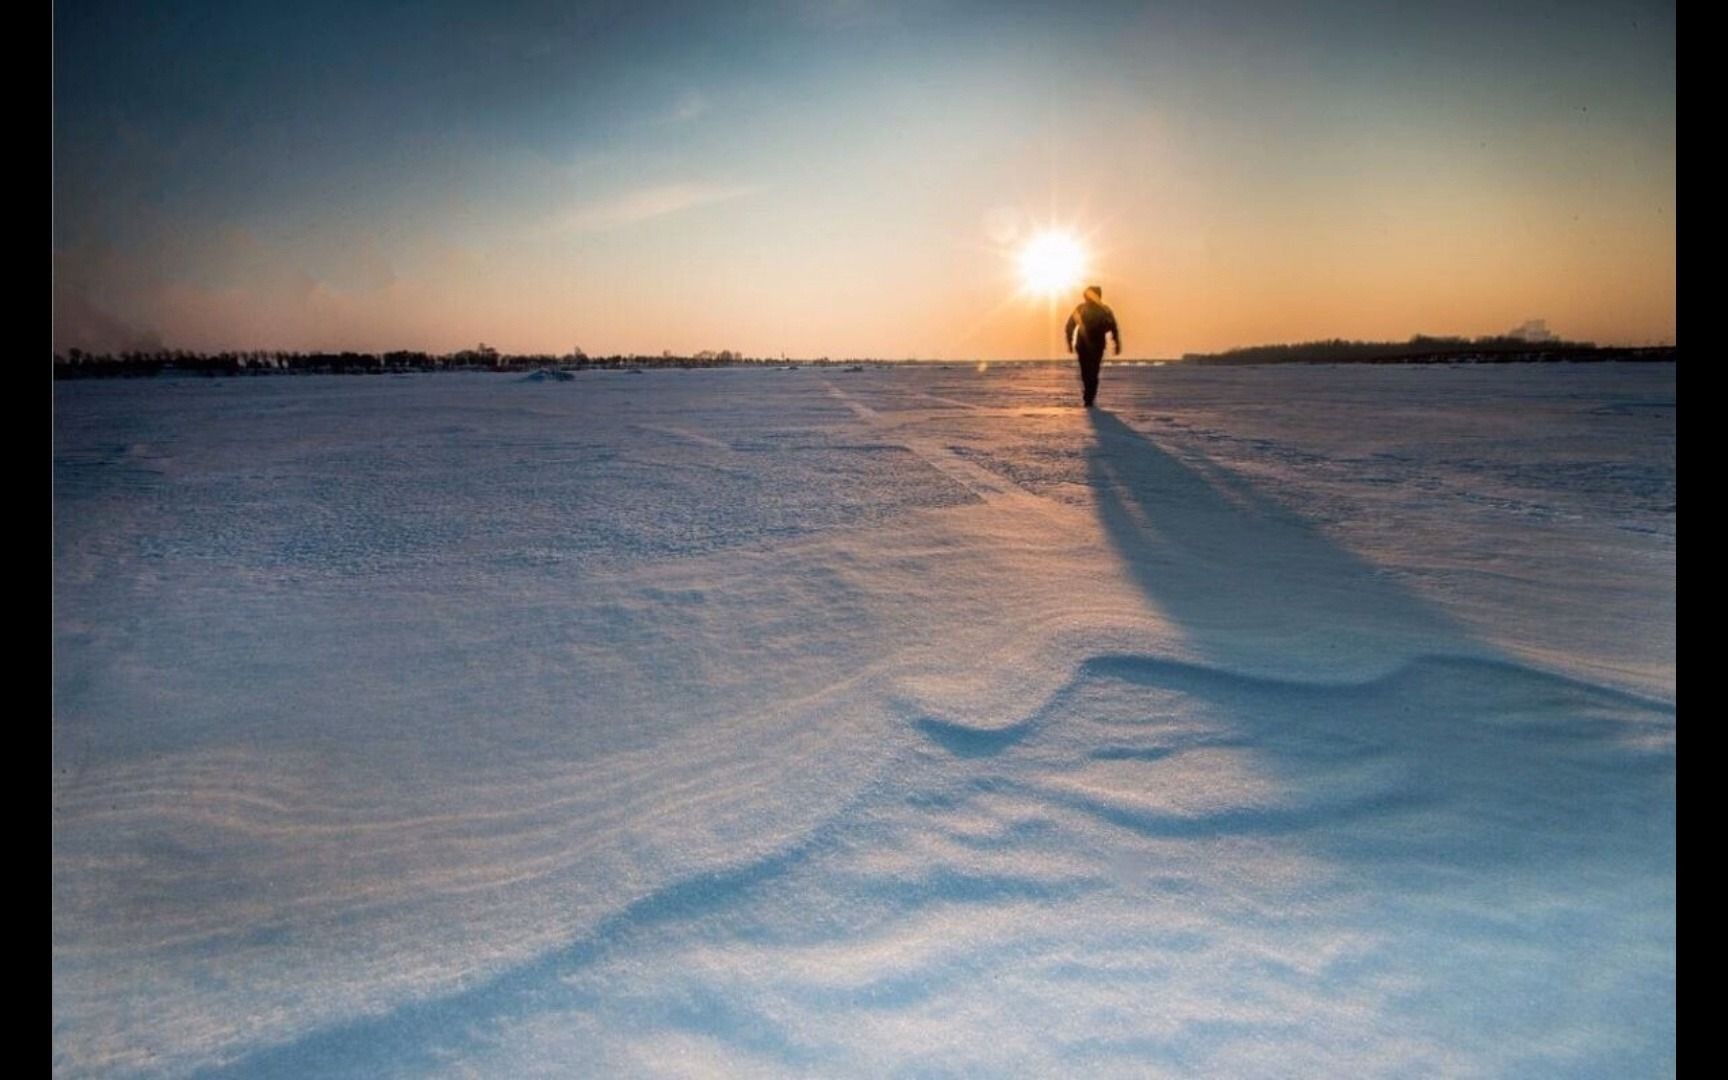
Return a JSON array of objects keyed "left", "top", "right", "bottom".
[{"left": 52, "top": 365, "right": 1674, "bottom": 1077}]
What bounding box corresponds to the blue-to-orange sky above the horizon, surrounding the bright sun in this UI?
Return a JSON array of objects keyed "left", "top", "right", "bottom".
[{"left": 52, "top": 0, "right": 1676, "bottom": 358}]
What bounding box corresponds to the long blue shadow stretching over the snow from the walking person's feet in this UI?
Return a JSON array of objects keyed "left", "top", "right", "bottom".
[{"left": 1071, "top": 411, "right": 1674, "bottom": 873}]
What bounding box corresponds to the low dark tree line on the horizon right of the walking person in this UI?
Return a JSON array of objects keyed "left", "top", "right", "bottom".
[{"left": 1182, "top": 334, "right": 1674, "bottom": 365}]
